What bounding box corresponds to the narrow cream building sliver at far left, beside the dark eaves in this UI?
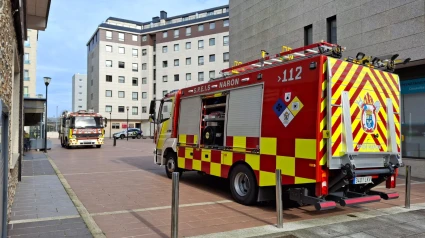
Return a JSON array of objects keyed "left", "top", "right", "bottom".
[{"left": 24, "top": 29, "right": 38, "bottom": 98}]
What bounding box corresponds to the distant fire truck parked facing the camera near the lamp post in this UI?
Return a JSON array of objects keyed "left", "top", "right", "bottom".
[{"left": 59, "top": 110, "right": 107, "bottom": 149}]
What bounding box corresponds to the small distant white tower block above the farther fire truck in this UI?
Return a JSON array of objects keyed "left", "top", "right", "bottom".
[{"left": 72, "top": 73, "right": 87, "bottom": 112}]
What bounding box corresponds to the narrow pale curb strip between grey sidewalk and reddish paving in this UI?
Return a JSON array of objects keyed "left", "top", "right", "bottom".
[{"left": 46, "top": 154, "right": 106, "bottom": 238}]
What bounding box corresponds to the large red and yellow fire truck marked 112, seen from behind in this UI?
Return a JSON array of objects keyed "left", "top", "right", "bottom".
[{"left": 150, "top": 42, "right": 402, "bottom": 210}]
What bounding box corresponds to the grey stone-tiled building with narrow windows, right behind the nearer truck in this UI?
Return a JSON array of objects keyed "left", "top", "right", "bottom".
[{"left": 229, "top": 0, "right": 425, "bottom": 158}]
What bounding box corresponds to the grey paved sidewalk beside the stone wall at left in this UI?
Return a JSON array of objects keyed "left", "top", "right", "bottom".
[{"left": 8, "top": 152, "right": 92, "bottom": 238}]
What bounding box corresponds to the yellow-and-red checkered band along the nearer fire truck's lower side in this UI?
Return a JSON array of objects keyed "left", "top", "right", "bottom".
[{"left": 177, "top": 137, "right": 317, "bottom": 186}]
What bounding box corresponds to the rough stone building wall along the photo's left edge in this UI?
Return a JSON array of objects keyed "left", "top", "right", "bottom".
[{"left": 0, "top": 0, "right": 22, "bottom": 219}]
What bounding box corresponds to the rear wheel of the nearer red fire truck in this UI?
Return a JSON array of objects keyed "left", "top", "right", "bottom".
[{"left": 230, "top": 164, "right": 258, "bottom": 205}]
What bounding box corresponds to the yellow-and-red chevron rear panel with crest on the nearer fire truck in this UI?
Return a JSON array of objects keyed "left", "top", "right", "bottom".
[{"left": 328, "top": 58, "right": 401, "bottom": 157}]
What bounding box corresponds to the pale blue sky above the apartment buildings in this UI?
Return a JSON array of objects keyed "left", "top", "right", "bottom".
[{"left": 36, "top": 0, "right": 229, "bottom": 117}]
